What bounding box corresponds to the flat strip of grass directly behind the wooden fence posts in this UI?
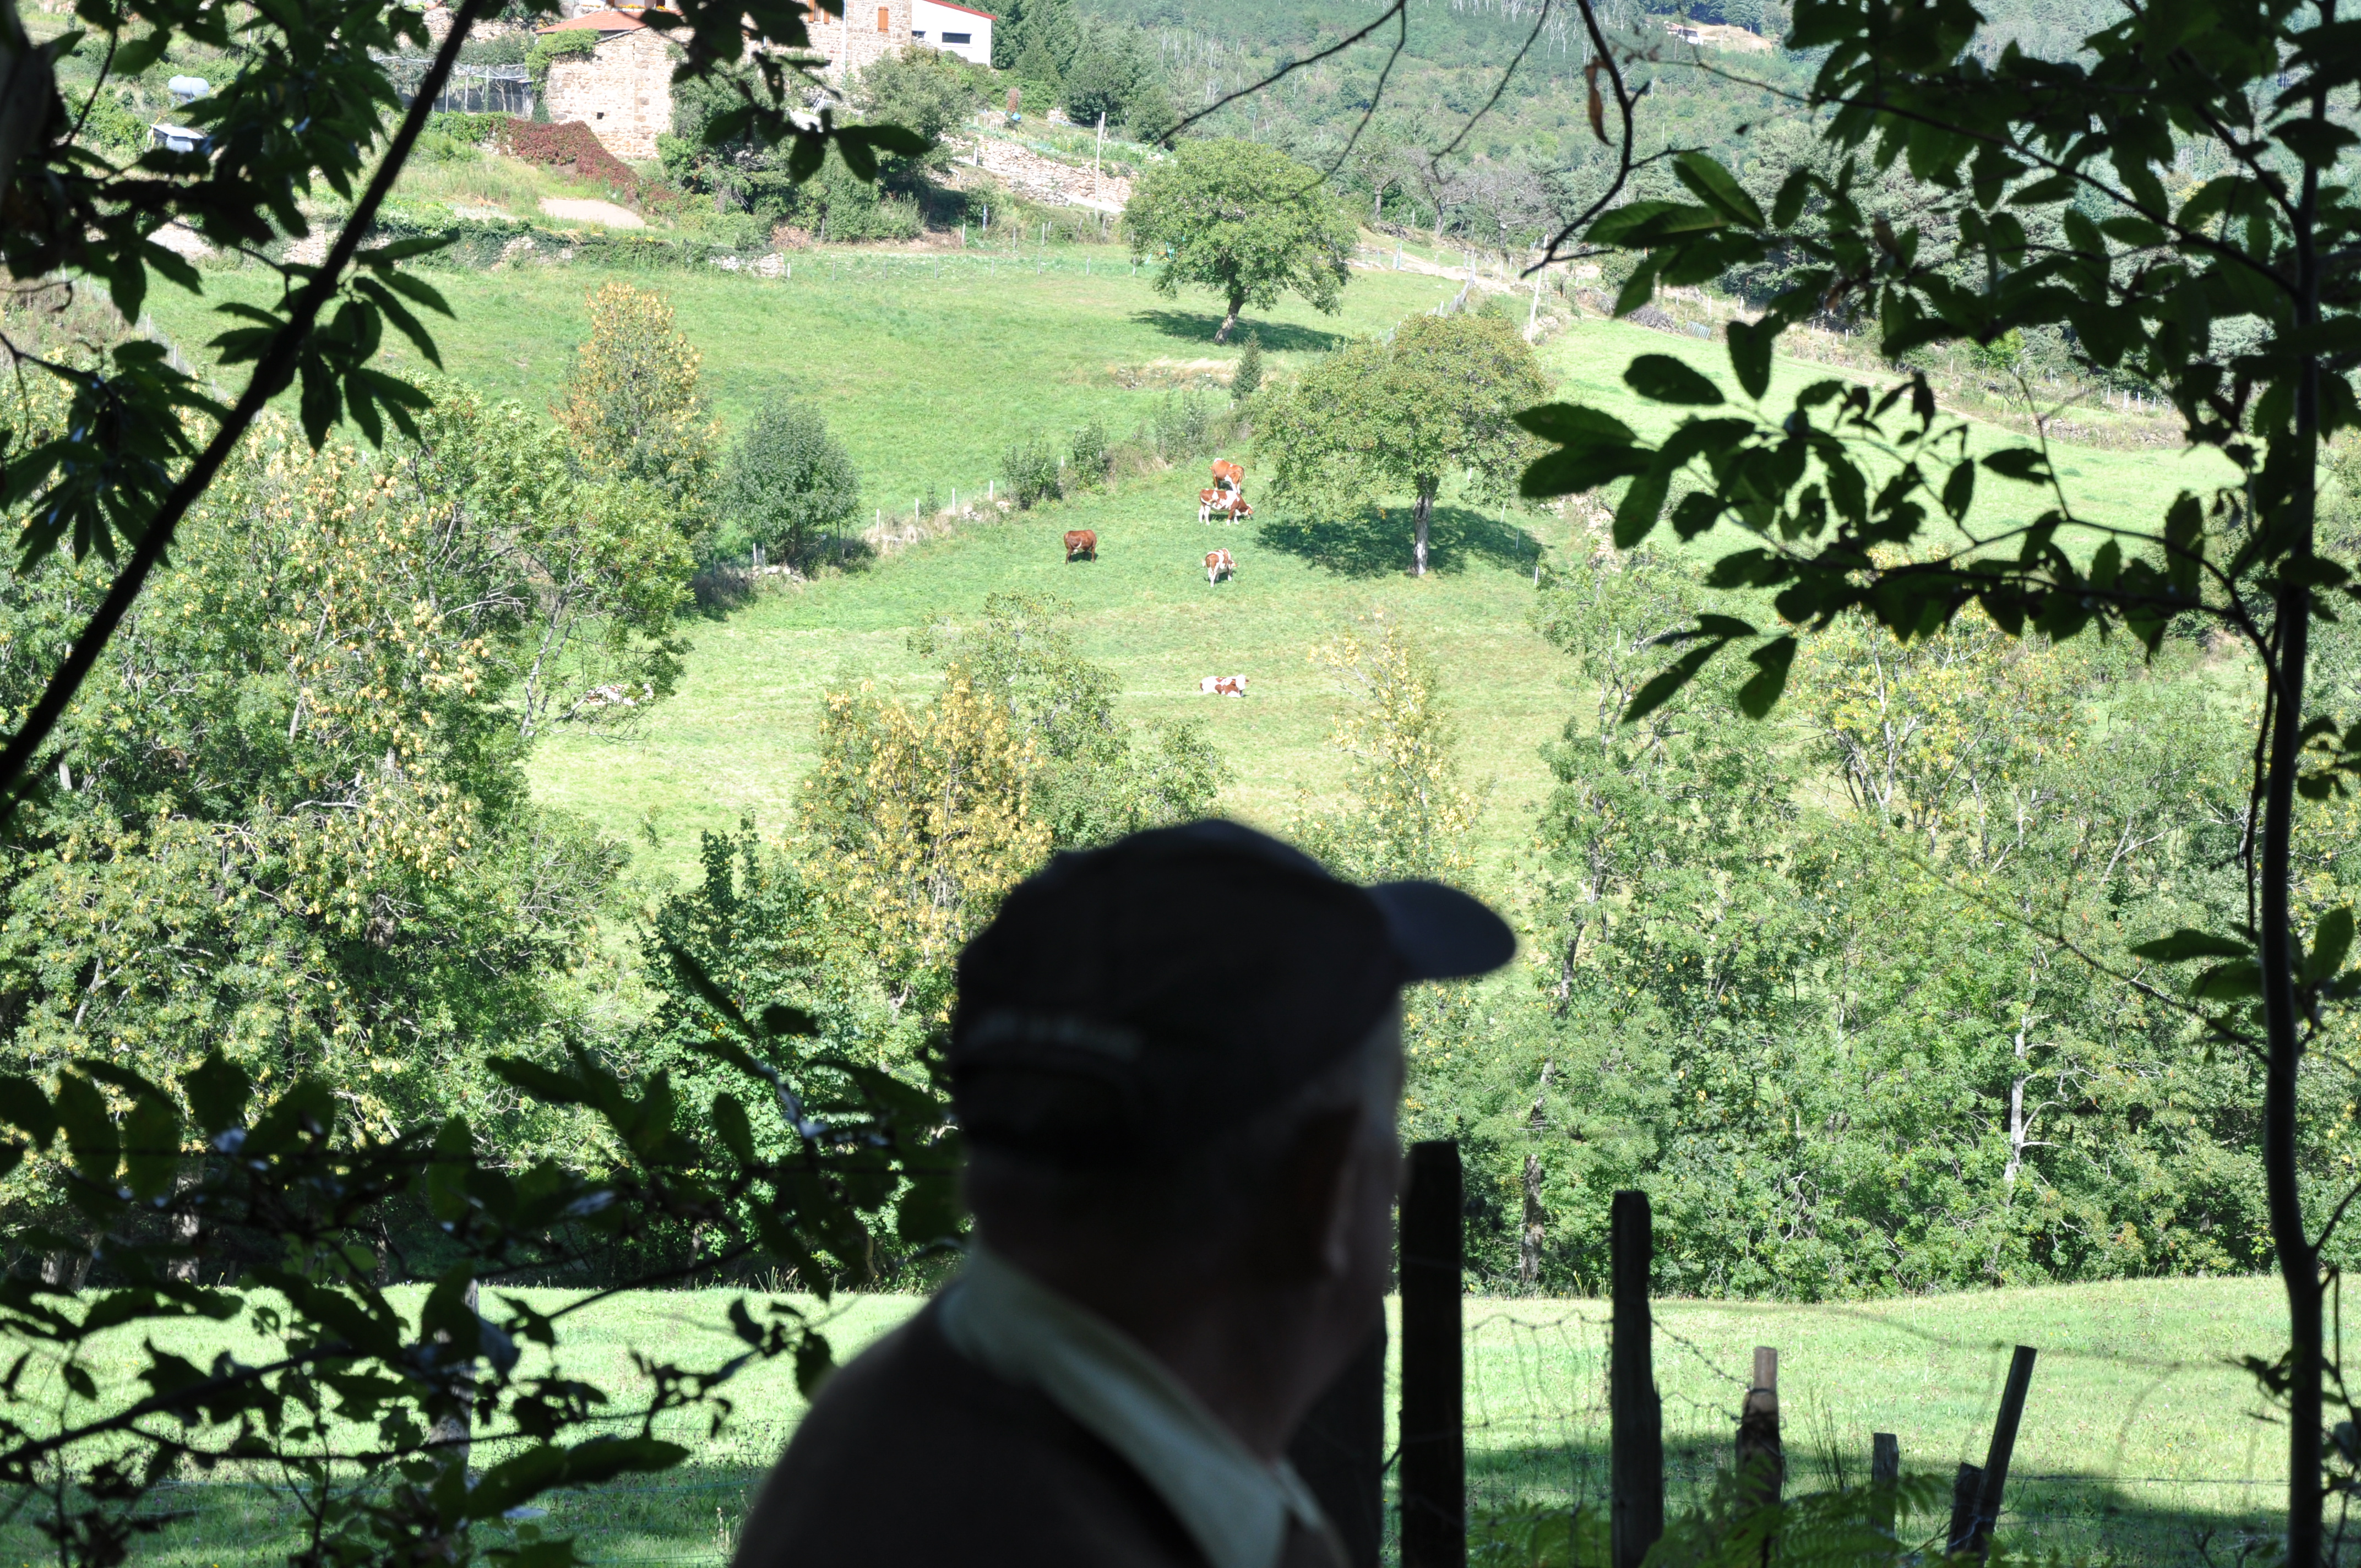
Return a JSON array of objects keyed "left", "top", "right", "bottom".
[{"left": 0, "top": 1277, "right": 2283, "bottom": 1568}]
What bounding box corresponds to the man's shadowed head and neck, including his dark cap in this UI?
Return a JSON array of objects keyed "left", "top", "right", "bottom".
[{"left": 951, "top": 822, "right": 1516, "bottom": 1435}]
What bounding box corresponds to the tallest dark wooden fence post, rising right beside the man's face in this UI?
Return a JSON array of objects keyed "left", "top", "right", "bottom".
[{"left": 1400, "top": 1138, "right": 1468, "bottom": 1568}]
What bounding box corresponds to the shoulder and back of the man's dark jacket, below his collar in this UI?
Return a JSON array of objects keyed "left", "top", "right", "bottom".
[{"left": 737, "top": 1308, "right": 1204, "bottom": 1568}]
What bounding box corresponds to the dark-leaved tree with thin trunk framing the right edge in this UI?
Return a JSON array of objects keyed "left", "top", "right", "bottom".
[{"left": 1525, "top": 0, "right": 2361, "bottom": 1563}]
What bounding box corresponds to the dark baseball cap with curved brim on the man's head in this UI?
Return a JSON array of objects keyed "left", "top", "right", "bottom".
[{"left": 949, "top": 822, "right": 1516, "bottom": 1169}]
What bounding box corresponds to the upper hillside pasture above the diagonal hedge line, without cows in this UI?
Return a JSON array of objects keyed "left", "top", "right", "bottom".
[{"left": 138, "top": 246, "right": 1457, "bottom": 517}]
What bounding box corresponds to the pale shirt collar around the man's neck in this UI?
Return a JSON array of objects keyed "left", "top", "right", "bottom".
[{"left": 937, "top": 1242, "right": 1334, "bottom": 1568}]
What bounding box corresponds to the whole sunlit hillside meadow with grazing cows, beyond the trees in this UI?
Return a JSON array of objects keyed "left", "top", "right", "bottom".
[{"left": 143, "top": 246, "right": 2212, "bottom": 874}]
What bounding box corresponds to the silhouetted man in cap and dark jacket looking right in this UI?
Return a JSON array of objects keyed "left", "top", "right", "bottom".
[{"left": 737, "top": 822, "right": 1516, "bottom": 1568}]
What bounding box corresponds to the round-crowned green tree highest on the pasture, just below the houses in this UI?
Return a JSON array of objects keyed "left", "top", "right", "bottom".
[{"left": 1124, "top": 141, "right": 1358, "bottom": 342}]
